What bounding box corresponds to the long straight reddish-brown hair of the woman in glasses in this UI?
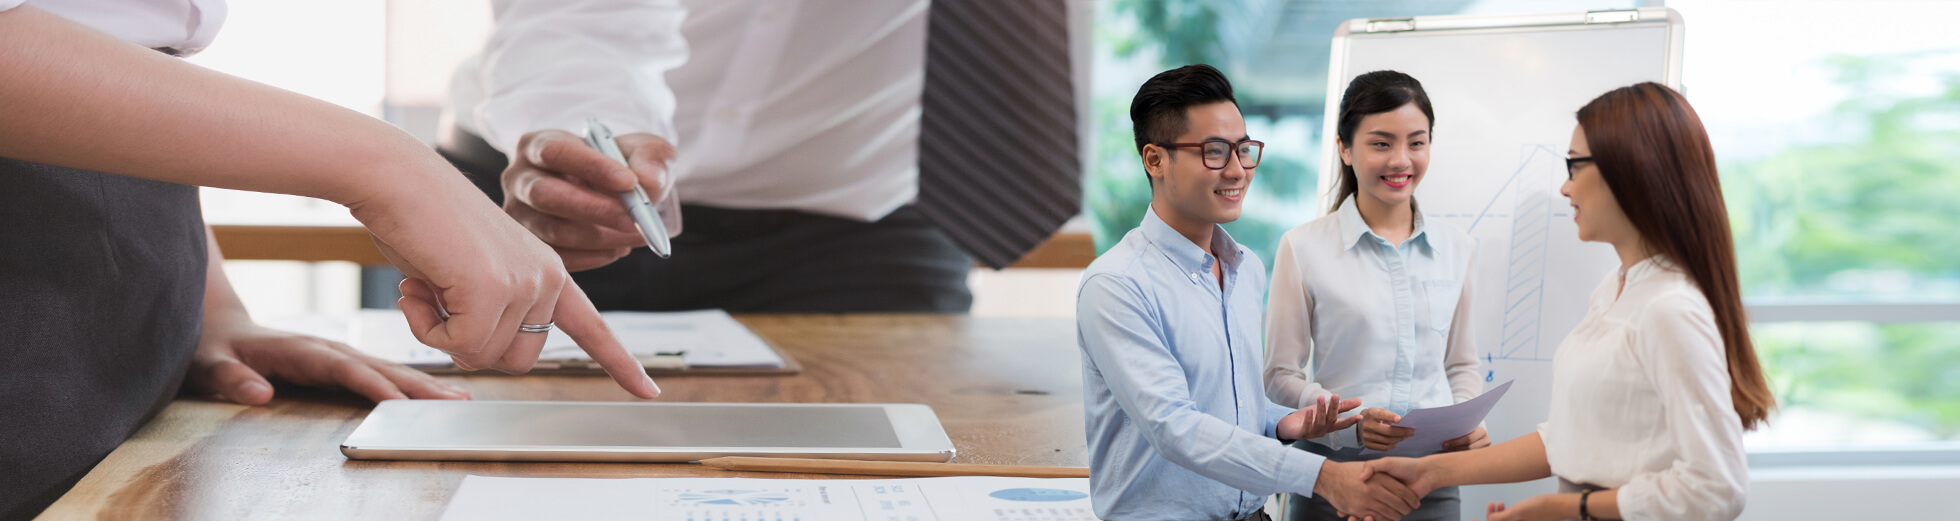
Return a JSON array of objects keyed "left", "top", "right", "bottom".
[{"left": 1578, "top": 82, "right": 1776, "bottom": 429}]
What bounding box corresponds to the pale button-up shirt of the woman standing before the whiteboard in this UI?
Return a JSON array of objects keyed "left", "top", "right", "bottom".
[{"left": 1264, "top": 198, "right": 1484, "bottom": 449}]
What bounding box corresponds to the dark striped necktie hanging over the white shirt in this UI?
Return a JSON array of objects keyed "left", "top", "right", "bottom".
[{"left": 919, "top": 0, "right": 1082, "bottom": 268}]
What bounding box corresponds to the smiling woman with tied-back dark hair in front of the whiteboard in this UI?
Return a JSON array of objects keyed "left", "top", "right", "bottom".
[{"left": 1264, "top": 71, "right": 1490, "bottom": 519}]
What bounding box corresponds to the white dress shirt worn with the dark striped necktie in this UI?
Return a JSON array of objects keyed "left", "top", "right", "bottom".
[{"left": 449, "top": 0, "right": 929, "bottom": 221}]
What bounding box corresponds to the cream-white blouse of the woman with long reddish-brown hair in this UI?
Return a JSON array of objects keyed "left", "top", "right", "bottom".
[{"left": 1539, "top": 257, "right": 1748, "bottom": 521}]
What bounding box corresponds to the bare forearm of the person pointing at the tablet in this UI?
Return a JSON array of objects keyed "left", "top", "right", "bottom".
[{"left": 0, "top": 6, "right": 447, "bottom": 204}]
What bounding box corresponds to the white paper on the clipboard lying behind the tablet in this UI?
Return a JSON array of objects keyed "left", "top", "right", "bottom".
[{"left": 270, "top": 309, "right": 782, "bottom": 368}]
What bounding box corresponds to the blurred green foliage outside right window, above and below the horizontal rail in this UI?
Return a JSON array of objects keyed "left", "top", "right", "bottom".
[{"left": 1703, "top": 53, "right": 1960, "bottom": 439}]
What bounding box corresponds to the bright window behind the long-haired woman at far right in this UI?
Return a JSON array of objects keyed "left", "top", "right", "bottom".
[{"left": 1668, "top": 0, "right": 1960, "bottom": 449}]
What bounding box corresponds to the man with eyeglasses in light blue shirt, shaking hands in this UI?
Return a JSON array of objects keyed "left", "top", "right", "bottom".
[{"left": 1076, "top": 65, "right": 1419, "bottom": 521}]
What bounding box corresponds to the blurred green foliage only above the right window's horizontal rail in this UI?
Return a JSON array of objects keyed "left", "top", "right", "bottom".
[{"left": 1732, "top": 53, "right": 1960, "bottom": 300}]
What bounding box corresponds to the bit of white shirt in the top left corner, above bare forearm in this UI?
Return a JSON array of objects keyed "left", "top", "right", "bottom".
[{"left": 0, "top": 0, "right": 225, "bottom": 57}]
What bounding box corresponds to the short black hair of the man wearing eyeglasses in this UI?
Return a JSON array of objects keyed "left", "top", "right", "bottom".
[{"left": 1129, "top": 63, "right": 1239, "bottom": 153}]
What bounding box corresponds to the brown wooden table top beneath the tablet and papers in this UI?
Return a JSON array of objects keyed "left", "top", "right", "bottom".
[{"left": 43, "top": 315, "right": 1088, "bottom": 519}]
